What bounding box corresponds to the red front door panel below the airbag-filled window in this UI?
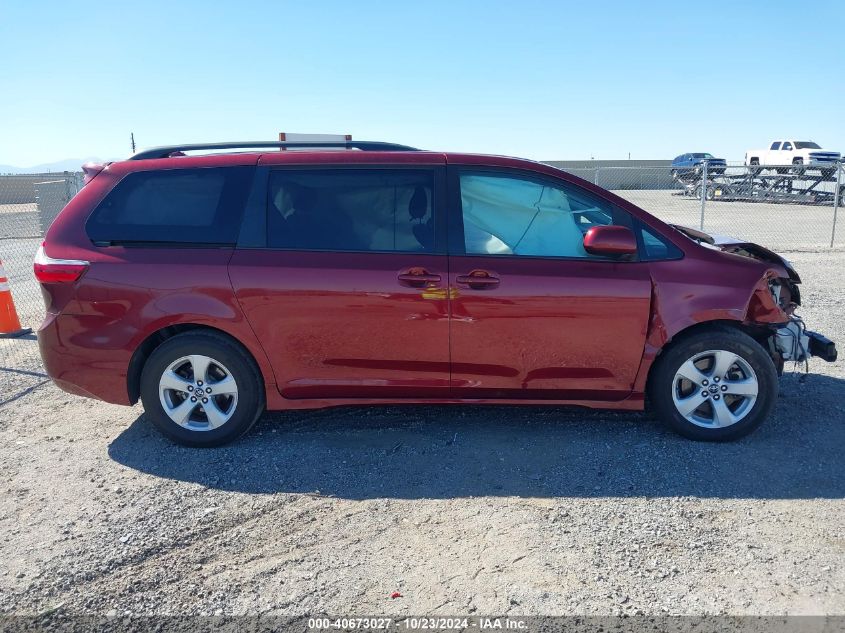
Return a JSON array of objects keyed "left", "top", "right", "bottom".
[{"left": 450, "top": 256, "right": 651, "bottom": 400}]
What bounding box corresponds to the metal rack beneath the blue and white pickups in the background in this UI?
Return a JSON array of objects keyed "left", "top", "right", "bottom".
[{"left": 673, "top": 163, "right": 845, "bottom": 205}]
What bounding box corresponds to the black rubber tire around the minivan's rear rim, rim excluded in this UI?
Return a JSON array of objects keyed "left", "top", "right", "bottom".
[{"left": 141, "top": 331, "right": 265, "bottom": 447}]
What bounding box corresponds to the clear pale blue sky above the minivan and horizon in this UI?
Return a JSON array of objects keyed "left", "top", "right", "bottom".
[{"left": 0, "top": 0, "right": 845, "bottom": 166}]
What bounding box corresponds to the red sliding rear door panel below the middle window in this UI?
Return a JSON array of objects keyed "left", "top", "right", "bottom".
[{"left": 224, "top": 249, "right": 449, "bottom": 398}]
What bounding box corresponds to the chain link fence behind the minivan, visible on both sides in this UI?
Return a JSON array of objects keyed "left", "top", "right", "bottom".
[{"left": 0, "top": 164, "right": 845, "bottom": 378}]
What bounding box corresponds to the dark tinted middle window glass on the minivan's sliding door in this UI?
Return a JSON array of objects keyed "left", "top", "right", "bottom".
[{"left": 267, "top": 169, "right": 434, "bottom": 252}]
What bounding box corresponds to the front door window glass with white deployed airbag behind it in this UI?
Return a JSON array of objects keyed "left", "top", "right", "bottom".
[{"left": 460, "top": 171, "right": 629, "bottom": 259}]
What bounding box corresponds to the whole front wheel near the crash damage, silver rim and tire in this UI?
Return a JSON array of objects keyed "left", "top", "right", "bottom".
[{"left": 649, "top": 328, "right": 778, "bottom": 441}]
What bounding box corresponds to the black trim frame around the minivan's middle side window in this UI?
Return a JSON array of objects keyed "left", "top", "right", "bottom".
[{"left": 246, "top": 163, "right": 448, "bottom": 256}]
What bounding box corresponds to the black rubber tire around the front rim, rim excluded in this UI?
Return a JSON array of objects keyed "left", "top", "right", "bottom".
[{"left": 648, "top": 327, "right": 778, "bottom": 442}]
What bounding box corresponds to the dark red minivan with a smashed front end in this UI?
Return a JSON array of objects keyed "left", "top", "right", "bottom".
[{"left": 35, "top": 142, "right": 836, "bottom": 446}]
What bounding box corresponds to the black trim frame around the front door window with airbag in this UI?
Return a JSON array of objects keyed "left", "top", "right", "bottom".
[{"left": 447, "top": 164, "right": 644, "bottom": 264}]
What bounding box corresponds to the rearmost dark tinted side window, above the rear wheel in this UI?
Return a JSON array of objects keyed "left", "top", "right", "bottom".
[{"left": 86, "top": 167, "right": 252, "bottom": 246}]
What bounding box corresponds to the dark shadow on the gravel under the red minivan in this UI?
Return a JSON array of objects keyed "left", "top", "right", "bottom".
[{"left": 109, "top": 375, "right": 845, "bottom": 499}]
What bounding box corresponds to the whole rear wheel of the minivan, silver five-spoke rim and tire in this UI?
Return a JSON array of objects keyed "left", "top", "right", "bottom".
[{"left": 141, "top": 332, "right": 264, "bottom": 446}]
